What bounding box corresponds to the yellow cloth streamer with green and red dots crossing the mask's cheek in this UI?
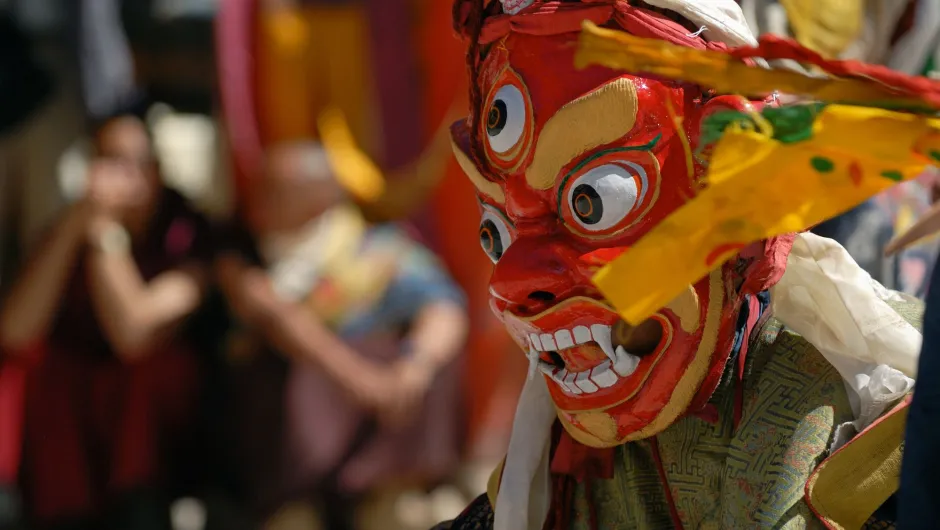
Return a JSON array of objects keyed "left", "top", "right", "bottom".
[{"left": 594, "top": 105, "right": 940, "bottom": 325}]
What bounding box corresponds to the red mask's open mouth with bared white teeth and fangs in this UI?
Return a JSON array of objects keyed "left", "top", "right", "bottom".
[{"left": 531, "top": 319, "right": 663, "bottom": 395}]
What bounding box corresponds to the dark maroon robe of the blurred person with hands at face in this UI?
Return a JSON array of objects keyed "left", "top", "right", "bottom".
[{"left": 0, "top": 192, "right": 209, "bottom": 521}]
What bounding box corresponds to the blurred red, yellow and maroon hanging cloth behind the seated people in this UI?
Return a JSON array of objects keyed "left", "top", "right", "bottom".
[{"left": 217, "top": 0, "right": 526, "bottom": 500}]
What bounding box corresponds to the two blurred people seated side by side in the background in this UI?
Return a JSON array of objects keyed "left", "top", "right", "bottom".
[{"left": 0, "top": 114, "right": 468, "bottom": 529}]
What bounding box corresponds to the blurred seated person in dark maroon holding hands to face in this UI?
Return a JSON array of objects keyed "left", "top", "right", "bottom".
[{"left": 0, "top": 115, "right": 208, "bottom": 530}]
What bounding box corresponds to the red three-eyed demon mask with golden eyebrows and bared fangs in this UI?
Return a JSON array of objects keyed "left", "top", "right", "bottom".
[{"left": 453, "top": 1, "right": 786, "bottom": 447}]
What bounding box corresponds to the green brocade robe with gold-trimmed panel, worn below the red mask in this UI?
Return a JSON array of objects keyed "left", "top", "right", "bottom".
[{"left": 441, "top": 303, "right": 922, "bottom": 530}]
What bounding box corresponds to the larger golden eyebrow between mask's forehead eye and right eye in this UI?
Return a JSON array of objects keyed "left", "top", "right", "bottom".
[{"left": 525, "top": 77, "right": 637, "bottom": 190}]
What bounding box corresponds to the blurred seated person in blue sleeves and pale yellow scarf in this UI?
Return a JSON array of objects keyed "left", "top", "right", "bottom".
[{"left": 210, "top": 137, "right": 468, "bottom": 530}]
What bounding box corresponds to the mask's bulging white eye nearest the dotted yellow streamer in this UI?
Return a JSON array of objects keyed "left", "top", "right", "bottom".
[{"left": 567, "top": 162, "right": 649, "bottom": 232}]
